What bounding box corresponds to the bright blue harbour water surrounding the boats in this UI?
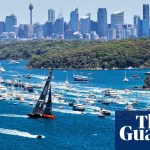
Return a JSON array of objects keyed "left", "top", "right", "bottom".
[{"left": 0, "top": 61, "right": 149, "bottom": 150}]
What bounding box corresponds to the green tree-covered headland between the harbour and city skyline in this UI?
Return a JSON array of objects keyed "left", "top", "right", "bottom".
[{"left": 0, "top": 38, "right": 150, "bottom": 69}]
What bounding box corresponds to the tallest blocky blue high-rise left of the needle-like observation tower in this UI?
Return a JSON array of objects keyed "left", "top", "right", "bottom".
[{"left": 5, "top": 14, "right": 17, "bottom": 32}]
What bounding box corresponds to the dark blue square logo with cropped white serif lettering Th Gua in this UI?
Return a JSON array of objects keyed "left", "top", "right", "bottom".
[{"left": 115, "top": 111, "right": 150, "bottom": 150}]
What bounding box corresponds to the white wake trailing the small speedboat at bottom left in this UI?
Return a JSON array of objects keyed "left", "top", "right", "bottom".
[{"left": 0, "top": 128, "right": 45, "bottom": 138}]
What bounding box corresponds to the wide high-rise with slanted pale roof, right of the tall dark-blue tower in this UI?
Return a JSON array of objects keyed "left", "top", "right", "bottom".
[{"left": 111, "top": 11, "right": 124, "bottom": 27}]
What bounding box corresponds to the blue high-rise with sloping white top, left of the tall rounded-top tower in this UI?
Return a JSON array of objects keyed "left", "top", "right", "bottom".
[{"left": 80, "top": 14, "right": 91, "bottom": 34}]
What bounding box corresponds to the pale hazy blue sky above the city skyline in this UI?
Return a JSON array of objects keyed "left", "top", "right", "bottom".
[{"left": 0, "top": 0, "right": 150, "bottom": 24}]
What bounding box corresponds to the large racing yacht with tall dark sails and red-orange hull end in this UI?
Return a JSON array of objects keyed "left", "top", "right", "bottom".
[{"left": 28, "top": 69, "right": 55, "bottom": 119}]
